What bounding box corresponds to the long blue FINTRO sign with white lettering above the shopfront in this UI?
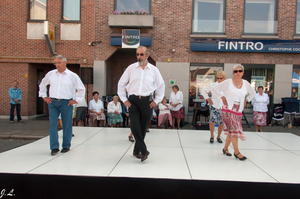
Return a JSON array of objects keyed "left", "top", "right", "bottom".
[{"left": 191, "top": 38, "right": 300, "bottom": 53}]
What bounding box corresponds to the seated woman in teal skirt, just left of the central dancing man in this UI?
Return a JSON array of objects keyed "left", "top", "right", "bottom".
[{"left": 107, "top": 95, "right": 123, "bottom": 127}]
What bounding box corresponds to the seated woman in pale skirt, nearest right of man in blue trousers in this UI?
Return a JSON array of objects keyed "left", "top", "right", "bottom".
[{"left": 89, "top": 91, "right": 106, "bottom": 126}]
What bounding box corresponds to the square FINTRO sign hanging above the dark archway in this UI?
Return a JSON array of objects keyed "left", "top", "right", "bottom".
[{"left": 122, "top": 29, "right": 140, "bottom": 48}]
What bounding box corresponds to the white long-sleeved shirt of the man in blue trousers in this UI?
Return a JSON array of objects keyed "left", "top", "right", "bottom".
[{"left": 39, "top": 69, "right": 85, "bottom": 102}]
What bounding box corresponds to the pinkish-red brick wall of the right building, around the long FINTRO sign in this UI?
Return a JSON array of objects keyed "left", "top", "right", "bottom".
[{"left": 95, "top": 0, "right": 300, "bottom": 64}]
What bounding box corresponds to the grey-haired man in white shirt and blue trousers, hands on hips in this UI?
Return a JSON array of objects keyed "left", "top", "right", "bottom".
[{"left": 39, "top": 55, "right": 85, "bottom": 155}]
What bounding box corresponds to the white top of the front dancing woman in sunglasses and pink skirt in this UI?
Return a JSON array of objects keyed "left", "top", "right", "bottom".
[{"left": 212, "top": 78, "right": 256, "bottom": 112}]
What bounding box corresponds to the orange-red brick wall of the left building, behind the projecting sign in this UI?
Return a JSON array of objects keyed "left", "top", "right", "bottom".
[{"left": 0, "top": 0, "right": 95, "bottom": 115}]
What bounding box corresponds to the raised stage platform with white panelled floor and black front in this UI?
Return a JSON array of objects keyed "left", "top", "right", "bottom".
[{"left": 0, "top": 127, "right": 300, "bottom": 198}]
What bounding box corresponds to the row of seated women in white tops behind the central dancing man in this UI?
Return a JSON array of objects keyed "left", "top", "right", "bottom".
[{"left": 69, "top": 85, "right": 184, "bottom": 131}]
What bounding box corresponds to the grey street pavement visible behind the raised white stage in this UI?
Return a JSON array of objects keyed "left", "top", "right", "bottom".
[{"left": 0, "top": 116, "right": 300, "bottom": 140}]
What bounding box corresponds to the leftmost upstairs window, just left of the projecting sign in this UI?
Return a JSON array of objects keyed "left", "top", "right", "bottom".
[{"left": 29, "top": 0, "right": 47, "bottom": 21}]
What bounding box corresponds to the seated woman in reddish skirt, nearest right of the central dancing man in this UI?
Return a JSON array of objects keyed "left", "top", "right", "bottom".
[{"left": 157, "top": 97, "right": 172, "bottom": 129}]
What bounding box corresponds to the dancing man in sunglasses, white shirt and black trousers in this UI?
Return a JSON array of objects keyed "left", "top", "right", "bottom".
[{"left": 118, "top": 46, "right": 165, "bottom": 162}]
